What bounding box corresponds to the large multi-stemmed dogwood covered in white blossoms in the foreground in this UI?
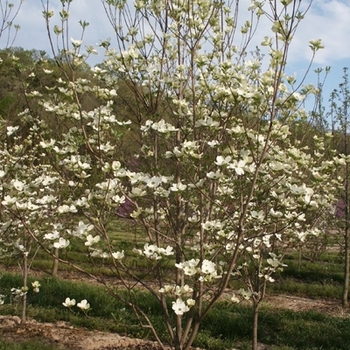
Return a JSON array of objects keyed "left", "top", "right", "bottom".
[{"left": 2, "top": 0, "right": 342, "bottom": 350}]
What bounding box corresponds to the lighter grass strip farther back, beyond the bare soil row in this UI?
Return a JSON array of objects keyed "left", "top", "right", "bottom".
[{"left": 0, "top": 227, "right": 344, "bottom": 282}]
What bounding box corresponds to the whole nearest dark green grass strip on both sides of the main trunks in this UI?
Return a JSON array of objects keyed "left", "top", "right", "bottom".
[{"left": 0, "top": 273, "right": 350, "bottom": 350}]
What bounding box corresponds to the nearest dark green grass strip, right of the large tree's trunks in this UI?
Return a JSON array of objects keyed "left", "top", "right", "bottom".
[{"left": 196, "top": 304, "right": 350, "bottom": 350}]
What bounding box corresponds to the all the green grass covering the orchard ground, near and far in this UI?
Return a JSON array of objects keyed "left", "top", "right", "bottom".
[{"left": 0, "top": 223, "right": 350, "bottom": 350}]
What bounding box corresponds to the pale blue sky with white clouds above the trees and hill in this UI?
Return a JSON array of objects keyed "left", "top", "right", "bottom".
[{"left": 0, "top": 0, "right": 350, "bottom": 108}]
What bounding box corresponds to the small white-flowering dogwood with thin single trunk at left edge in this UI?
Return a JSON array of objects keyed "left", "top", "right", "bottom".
[{"left": 0, "top": 118, "right": 55, "bottom": 322}]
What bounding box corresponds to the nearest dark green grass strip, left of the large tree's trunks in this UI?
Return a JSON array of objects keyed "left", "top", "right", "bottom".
[{"left": 0, "top": 273, "right": 165, "bottom": 338}]
